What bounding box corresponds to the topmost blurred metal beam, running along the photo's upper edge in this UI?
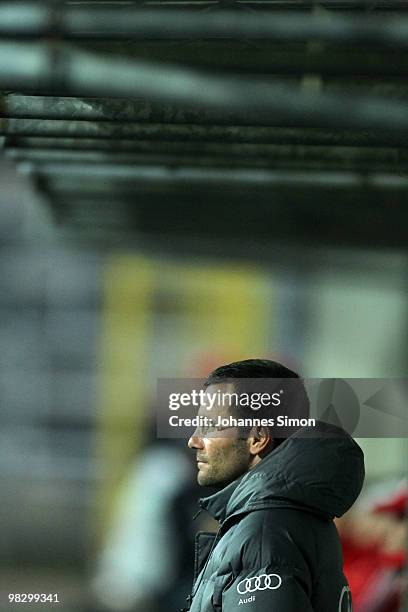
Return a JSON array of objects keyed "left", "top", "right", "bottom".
[{"left": 0, "top": 2, "right": 408, "bottom": 49}]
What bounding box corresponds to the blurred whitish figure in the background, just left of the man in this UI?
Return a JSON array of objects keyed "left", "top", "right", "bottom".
[{"left": 92, "top": 443, "right": 201, "bottom": 612}]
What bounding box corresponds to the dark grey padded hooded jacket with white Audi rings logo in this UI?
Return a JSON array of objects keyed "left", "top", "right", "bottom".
[{"left": 186, "top": 424, "right": 364, "bottom": 612}]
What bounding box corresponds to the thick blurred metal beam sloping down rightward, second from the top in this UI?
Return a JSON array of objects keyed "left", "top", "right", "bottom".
[{"left": 0, "top": 43, "right": 408, "bottom": 135}]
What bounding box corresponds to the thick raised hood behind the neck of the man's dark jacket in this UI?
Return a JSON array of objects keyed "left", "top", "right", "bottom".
[{"left": 200, "top": 422, "right": 365, "bottom": 523}]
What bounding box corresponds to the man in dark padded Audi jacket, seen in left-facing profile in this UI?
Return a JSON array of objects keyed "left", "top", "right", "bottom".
[{"left": 188, "top": 360, "right": 364, "bottom": 612}]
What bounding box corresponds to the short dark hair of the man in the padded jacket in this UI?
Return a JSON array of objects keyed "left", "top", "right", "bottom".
[{"left": 204, "top": 359, "right": 309, "bottom": 449}]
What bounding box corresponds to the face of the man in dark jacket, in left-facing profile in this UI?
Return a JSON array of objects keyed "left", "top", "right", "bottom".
[{"left": 188, "top": 383, "right": 253, "bottom": 486}]
